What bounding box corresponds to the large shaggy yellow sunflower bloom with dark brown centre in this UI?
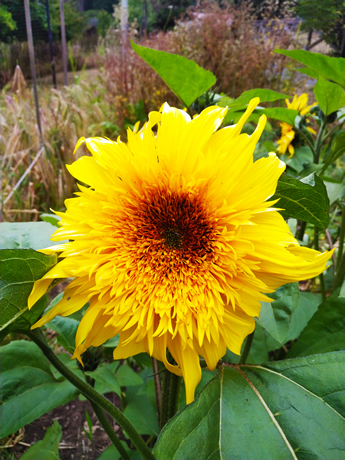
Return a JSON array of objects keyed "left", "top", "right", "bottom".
[{"left": 29, "top": 98, "right": 331, "bottom": 403}]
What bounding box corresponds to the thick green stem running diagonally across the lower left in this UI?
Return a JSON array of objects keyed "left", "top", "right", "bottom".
[{"left": 26, "top": 330, "right": 155, "bottom": 460}]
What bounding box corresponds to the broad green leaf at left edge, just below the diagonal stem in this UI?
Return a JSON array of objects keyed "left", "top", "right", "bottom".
[{"left": 0, "top": 340, "right": 79, "bottom": 438}]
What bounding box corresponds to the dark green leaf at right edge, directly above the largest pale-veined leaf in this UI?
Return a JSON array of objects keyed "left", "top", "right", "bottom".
[{"left": 287, "top": 289, "right": 345, "bottom": 358}]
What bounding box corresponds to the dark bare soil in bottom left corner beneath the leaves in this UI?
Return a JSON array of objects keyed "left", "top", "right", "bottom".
[{"left": 0, "top": 393, "right": 124, "bottom": 460}]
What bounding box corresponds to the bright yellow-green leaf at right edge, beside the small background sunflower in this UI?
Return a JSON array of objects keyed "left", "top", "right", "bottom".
[{"left": 314, "top": 78, "right": 345, "bottom": 116}]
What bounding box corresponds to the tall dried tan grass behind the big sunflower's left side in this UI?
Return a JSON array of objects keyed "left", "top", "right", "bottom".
[{"left": 0, "top": 70, "right": 118, "bottom": 221}]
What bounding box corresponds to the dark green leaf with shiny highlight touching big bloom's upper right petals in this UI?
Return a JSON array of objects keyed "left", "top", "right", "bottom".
[{"left": 272, "top": 173, "right": 329, "bottom": 230}]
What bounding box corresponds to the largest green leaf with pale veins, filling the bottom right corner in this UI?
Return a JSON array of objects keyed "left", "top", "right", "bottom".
[{"left": 154, "top": 352, "right": 344, "bottom": 460}]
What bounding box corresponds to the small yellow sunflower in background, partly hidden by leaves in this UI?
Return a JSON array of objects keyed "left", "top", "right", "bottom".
[{"left": 277, "top": 93, "right": 317, "bottom": 158}]
